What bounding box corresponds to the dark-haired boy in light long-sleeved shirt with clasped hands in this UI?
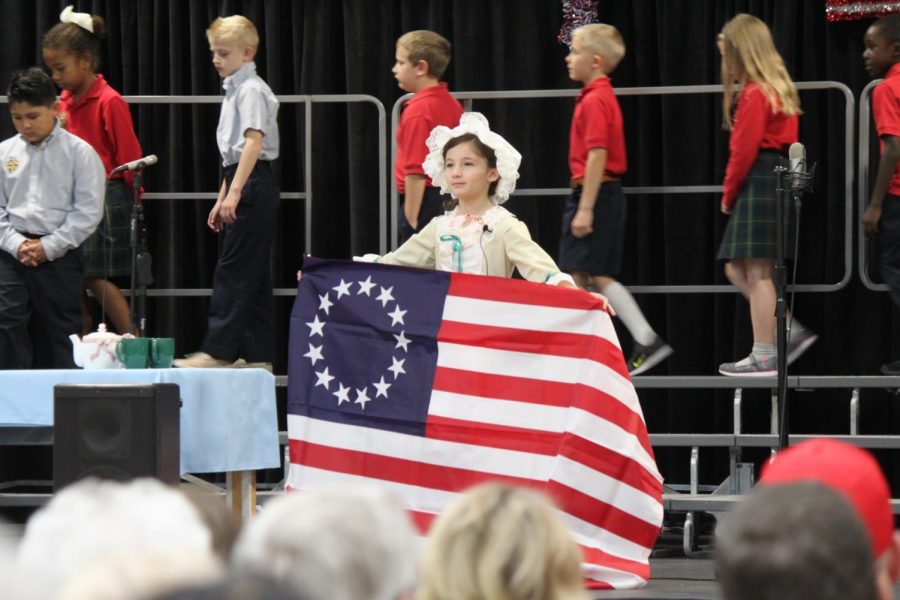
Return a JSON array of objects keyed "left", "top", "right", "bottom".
[{"left": 0, "top": 67, "right": 106, "bottom": 369}]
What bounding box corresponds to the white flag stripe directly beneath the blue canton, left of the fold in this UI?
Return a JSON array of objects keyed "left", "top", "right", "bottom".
[{"left": 288, "top": 414, "right": 556, "bottom": 481}]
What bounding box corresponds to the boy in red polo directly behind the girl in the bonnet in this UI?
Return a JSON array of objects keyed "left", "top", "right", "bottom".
[{"left": 391, "top": 30, "right": 462, "bottom": 244}]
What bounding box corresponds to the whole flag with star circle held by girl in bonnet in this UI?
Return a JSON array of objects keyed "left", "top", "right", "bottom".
[{"left": 288, "top": 259, "right": 663, "bottom": 588}]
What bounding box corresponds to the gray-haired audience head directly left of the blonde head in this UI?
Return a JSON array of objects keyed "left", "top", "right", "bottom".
[{"left": 232, "top": 484, "right": 416, "bottom": 600}]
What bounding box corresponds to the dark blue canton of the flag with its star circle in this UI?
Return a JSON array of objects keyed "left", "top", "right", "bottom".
[{"left": 288, "top": 258, "right": 449, "bottom": 435}]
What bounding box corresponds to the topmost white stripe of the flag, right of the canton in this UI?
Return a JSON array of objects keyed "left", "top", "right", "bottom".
[{"left": 443, "top": 296, "right": 619, "bottom": 348}]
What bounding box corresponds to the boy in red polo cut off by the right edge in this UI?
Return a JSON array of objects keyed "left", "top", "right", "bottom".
[{"left": 862, "top": 15, "right": 900, "bottom": 375}]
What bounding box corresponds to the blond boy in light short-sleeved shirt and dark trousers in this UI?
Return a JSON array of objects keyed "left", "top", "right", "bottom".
[{"left": 175, "top": 15, "right": 279, "bottom": 371}]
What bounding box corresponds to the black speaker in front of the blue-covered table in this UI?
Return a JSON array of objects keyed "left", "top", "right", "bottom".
[{"left": 53, "top": 383, "right": 181, "bottom": 490}]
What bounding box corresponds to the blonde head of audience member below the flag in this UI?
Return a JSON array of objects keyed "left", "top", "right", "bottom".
[{"left": 417, "top": 483, "right": 588, "bottom": 600}]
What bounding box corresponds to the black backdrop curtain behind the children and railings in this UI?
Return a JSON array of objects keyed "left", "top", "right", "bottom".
[{"left": 0, "top": 0, "right": 900, "bottom": 490}]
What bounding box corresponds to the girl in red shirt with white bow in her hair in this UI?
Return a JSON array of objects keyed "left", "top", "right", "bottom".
[{"left": 43, "top": 6, "right": 142, "bottom": 333}]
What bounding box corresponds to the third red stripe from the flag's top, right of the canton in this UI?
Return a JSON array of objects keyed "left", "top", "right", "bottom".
[{"left": 432, "top": 367, "right": 653, "bottom": 456}]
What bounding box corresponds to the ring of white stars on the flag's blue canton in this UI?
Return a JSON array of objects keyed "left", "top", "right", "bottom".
[{"left": 303, "top": 275, "right": 411, "bottom": 410}]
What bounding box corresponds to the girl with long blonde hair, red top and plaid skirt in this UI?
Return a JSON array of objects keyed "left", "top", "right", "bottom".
[{"left": 718, "top": 14, "right": 816, "bottom": 377}]
